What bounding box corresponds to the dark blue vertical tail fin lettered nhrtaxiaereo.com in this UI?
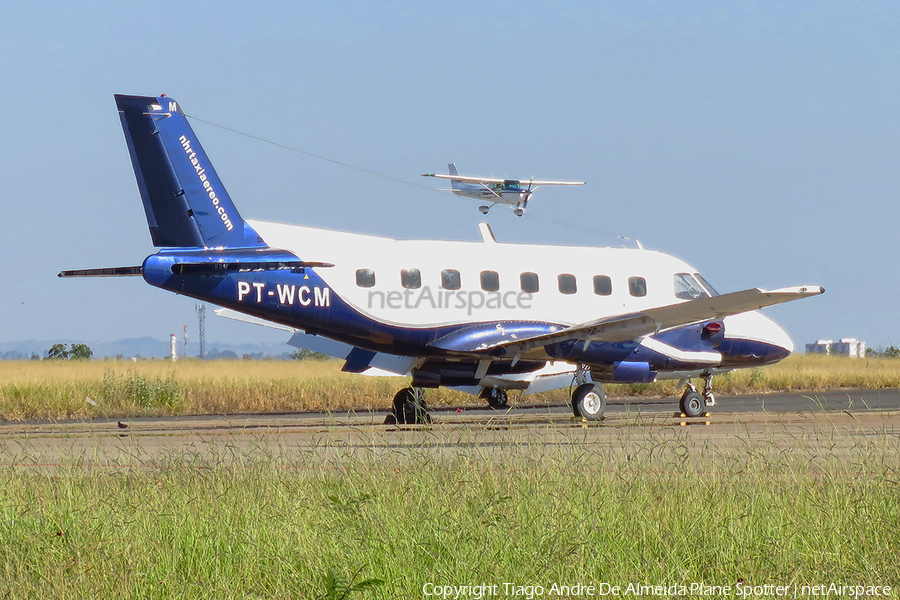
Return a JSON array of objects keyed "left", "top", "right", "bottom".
[{"left": 116, "top": 94, "right": 266, "bottom": 248}]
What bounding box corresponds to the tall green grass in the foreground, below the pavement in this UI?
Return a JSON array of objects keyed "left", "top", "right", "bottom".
[{"left": 0, "top": 429, "right": 900, "bottom": 598}]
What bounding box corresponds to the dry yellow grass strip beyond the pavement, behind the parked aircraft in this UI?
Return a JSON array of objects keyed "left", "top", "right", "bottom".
[{"left": 0, "top": 356, "right": 900, "bottom": 420}]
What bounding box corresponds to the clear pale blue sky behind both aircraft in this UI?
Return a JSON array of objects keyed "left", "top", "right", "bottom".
[{"left": 0, "top": 0, "right": 900, "bottom": 346}]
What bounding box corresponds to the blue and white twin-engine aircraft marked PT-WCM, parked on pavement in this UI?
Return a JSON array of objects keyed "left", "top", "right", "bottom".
[{"left": 60, "top": 96, "right": 824, "bottom": 423}]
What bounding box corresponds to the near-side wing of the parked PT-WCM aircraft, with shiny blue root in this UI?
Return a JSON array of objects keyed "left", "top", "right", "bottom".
[{"left": 429, "top": 286, "right": 825, "bottom": 356}]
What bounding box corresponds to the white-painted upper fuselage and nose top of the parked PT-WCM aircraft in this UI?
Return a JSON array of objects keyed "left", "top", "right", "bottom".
[{"left": 248, "top": 221, "right": 793, "bottom": 351}]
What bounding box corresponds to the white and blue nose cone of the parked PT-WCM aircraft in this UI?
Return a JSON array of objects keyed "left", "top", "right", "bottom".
[{"left": 718, "top": 311, "right": 794, "bottom": 366}]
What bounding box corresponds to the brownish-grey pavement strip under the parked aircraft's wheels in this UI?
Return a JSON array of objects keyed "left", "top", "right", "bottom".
[{"left": 0, "top": 389, "right": 900, "bottom": 468}]
